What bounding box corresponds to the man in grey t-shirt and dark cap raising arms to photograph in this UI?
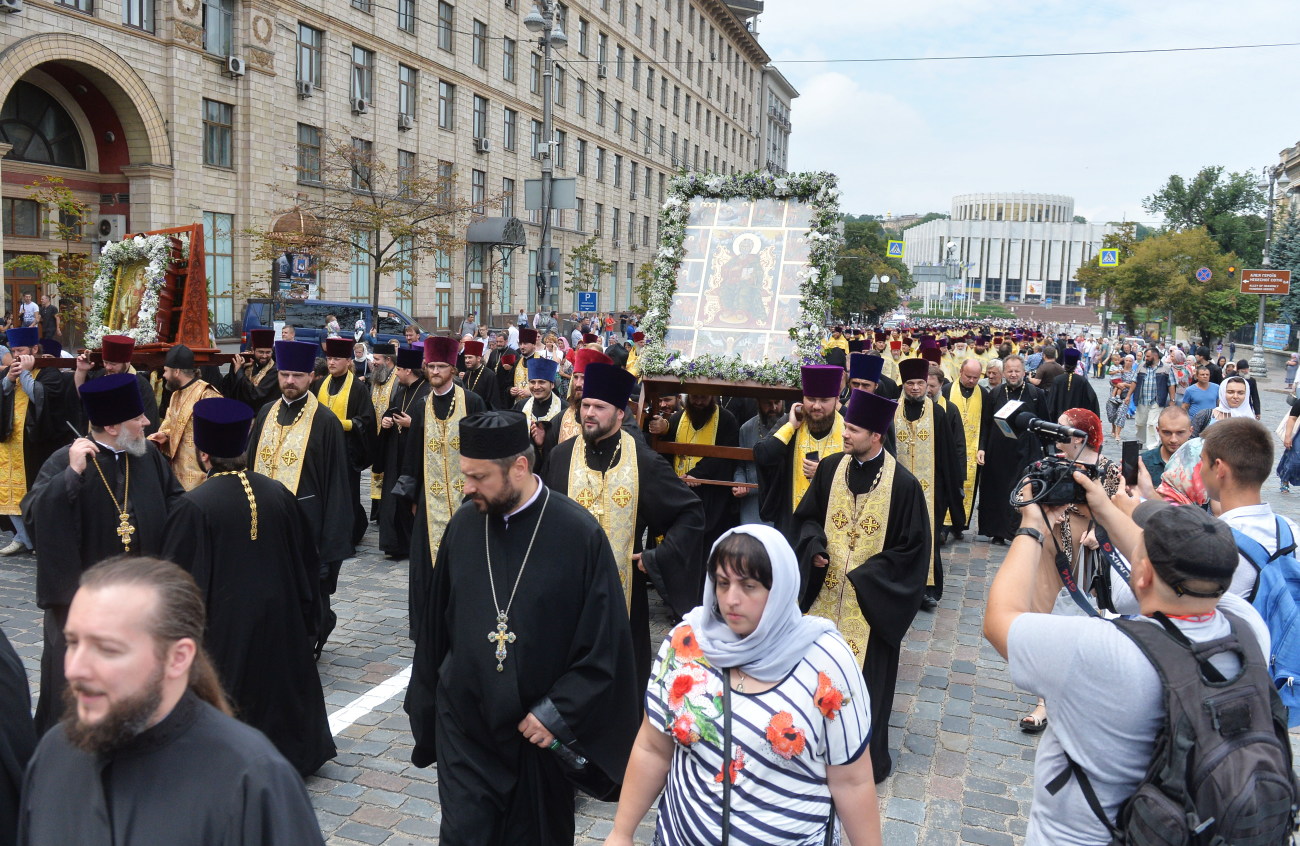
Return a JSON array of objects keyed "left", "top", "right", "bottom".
[{"left": 984, "top": 473, "right": 1270, "bottom": 846}]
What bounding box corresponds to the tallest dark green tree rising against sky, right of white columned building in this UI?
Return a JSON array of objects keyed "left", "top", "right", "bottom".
[{"left": 1143, "top": 165, "right": 1268, "bottom": 260}]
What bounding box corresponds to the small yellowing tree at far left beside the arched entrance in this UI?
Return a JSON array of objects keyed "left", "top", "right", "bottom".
[{"left": 4, "top": 175, "right": 96, "bottom": 327}]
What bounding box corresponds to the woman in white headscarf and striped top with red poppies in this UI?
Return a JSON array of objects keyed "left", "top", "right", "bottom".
[{"left": 605, "top": 525, "right": 880, "bottom": 846}]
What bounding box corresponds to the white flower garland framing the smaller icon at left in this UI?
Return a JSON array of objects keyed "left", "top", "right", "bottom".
[{"left": 86, "top": 235, "right": 190, "bottom": 350}]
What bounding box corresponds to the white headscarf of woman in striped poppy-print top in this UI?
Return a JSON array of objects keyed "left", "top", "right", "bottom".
[{"left": 685, "top": 524, "right": 835, "bottom": 681}]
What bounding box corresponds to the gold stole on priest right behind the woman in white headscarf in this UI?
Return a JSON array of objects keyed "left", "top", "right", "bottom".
[{"left": 809, "top": 452, "right": 896, "bottom": 655}]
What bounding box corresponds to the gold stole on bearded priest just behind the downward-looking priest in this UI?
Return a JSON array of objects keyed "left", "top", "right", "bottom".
[{"left": 568, "top": 430, "right": 641, "bottom": 612}]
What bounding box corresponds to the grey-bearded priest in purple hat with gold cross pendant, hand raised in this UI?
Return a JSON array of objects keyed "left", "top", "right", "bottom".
[{"left": 22, "top": 373, "right": 185, "bottom": 734}]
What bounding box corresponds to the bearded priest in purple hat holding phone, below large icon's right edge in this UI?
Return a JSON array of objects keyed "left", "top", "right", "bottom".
[{"left": 754, "top": 364, "right": 844, "bottom": 535}]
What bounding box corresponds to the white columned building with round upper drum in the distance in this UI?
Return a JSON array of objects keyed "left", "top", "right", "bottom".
[{"left": 904, "top": 192, "right": 1117, "bottom": 304}]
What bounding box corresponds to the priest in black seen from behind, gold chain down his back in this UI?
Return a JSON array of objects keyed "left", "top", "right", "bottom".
[{"left": 163, "top": 398, "right": 335, "bottom": 776}]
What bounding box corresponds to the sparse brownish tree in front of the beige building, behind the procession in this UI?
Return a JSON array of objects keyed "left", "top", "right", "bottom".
[{"left": 246, "top": 138, "right": 486, "bottom": 307}]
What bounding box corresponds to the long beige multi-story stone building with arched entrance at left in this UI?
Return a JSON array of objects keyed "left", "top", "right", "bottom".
[{"left": 0, "top": 0, "right": 788, "bottom": 329}]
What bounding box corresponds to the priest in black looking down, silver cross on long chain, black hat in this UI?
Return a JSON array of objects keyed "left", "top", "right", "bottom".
[{"left": 406, "top": 411, "right": 642, "bottom": 846}]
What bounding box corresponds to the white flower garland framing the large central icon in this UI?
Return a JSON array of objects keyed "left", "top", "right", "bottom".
[{"left": 640, "top": 170, "right": 842, "bottom": 386}]
